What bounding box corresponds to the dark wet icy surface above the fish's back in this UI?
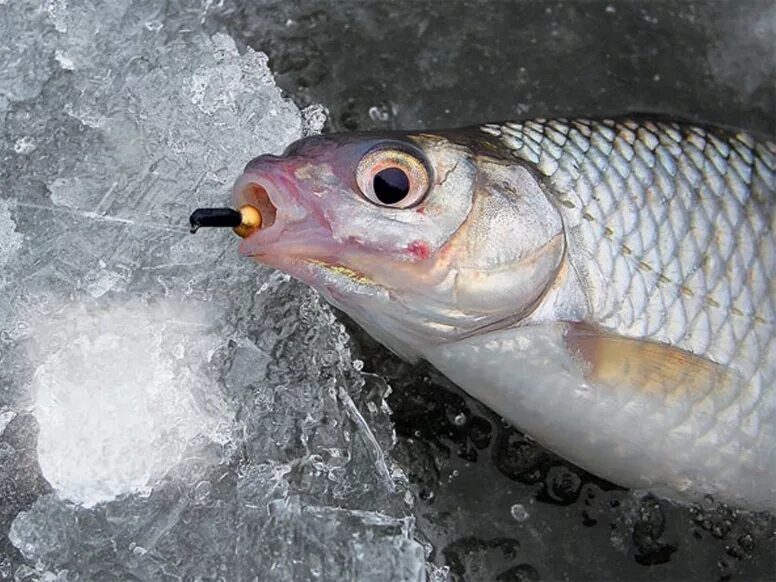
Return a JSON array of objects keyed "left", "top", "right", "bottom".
[{"left": 214, "top": 0, "right": 776, "bottom": 136}]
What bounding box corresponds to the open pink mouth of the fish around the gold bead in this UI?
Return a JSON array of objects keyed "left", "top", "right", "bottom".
[{"left": 232, "top": 171, "right": 372, "bottom": 285}]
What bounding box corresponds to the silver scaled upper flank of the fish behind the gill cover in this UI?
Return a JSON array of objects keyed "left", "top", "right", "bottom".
[{"left": 492, "top": 120, "right": 776, "bottom": 380}]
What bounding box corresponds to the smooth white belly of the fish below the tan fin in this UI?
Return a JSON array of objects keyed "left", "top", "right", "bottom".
[{"left": 426, "top": 324, "right": 776, "bottom": 510}]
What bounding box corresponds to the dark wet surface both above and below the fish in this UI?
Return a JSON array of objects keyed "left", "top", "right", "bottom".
[{"left": 210, "top": 0, "right": 776, "bottom": 581}]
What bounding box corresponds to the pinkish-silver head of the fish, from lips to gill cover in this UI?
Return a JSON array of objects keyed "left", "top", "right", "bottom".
[{"left": 232, "top": 132, "right": 565, "bottom": 360}]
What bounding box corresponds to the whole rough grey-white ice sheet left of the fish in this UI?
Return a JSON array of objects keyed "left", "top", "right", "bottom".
[{"left": 0, "top": 0, "right": 426, "bottom": 581}]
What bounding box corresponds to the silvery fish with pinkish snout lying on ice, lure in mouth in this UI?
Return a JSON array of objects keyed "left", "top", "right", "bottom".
[{"left": 226, "top": 116, "right": 776, "bottom": 511}]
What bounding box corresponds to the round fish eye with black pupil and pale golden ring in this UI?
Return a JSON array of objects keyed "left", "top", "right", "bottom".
[{"left": 356, "top": 148, "right": 431, "bottom": 208}]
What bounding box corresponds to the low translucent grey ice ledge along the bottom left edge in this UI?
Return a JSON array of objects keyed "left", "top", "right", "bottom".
[{"left": 10, "top": 492, "right": 424, "bottom": 582}]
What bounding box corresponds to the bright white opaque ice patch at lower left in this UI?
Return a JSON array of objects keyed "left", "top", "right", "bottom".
[{"left": 32, "top": 300, "right": 232, "bottom": 506}]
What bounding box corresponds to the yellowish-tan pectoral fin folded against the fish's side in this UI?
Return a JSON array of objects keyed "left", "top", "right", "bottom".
[{"left": 564, "top": 323, "right": 738, "bottom": 396}]
